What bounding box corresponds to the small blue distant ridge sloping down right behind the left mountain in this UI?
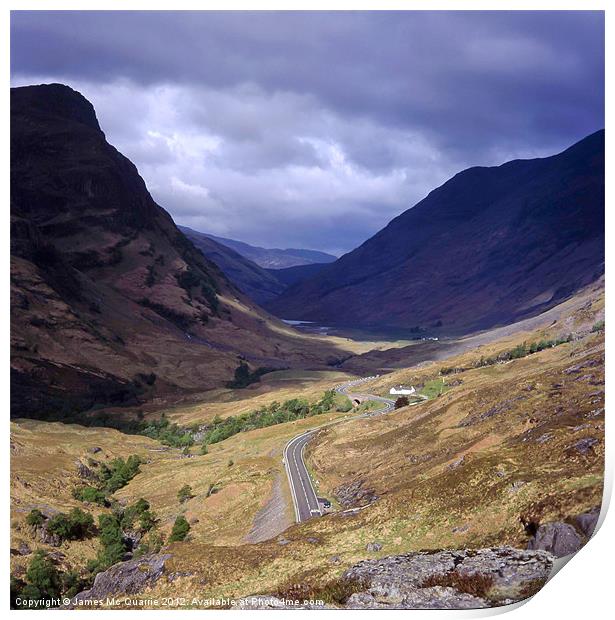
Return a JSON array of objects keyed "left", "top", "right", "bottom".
[{"left": 178, "top": 226, "right": 286, "bottom": 304}]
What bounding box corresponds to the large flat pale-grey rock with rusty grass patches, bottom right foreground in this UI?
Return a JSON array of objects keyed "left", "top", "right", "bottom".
[{"left": 343, "top": 547, "right": 553, "bottom": 609}]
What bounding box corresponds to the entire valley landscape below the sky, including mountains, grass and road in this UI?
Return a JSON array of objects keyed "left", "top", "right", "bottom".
[{"left": 10, "top": 84, "right": 605, "bottom": 609}]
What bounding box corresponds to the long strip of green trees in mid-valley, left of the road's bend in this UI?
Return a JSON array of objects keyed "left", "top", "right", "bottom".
[{"left": 202, "top": 390, "right": 352, "bottom": 454}]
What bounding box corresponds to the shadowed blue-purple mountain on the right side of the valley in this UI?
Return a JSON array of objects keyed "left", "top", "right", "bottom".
[{"left": 268, "top": 131, "right": 604, "bottom": 333}]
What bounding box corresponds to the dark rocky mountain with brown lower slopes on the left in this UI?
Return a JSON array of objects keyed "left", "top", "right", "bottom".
[{"left": 10, "top": 84, "right": 336, "bottom": 417}]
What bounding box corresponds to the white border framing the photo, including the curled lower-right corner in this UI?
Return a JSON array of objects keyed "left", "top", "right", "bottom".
[{"left": 0, "top": 0, "right": 615, "bottom": 620}]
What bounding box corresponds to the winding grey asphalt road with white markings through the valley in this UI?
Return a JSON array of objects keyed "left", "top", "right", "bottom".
[{"left": 284, "top": 377, "right": 395, "bottom": 523}]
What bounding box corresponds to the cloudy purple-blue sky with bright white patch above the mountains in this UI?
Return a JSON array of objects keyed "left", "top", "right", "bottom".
[{"left": 11, "top": 11, "right": 604, "bottom": 254}]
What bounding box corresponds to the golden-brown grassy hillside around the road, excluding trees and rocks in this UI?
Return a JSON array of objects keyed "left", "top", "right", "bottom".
[{"left": 12, "top": 292, "right": 604, "bottom": 608}]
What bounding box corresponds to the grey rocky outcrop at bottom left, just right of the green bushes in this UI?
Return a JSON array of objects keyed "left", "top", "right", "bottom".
[{"left": 68, "top": 553, "right": 171, "bottom": 608}]
